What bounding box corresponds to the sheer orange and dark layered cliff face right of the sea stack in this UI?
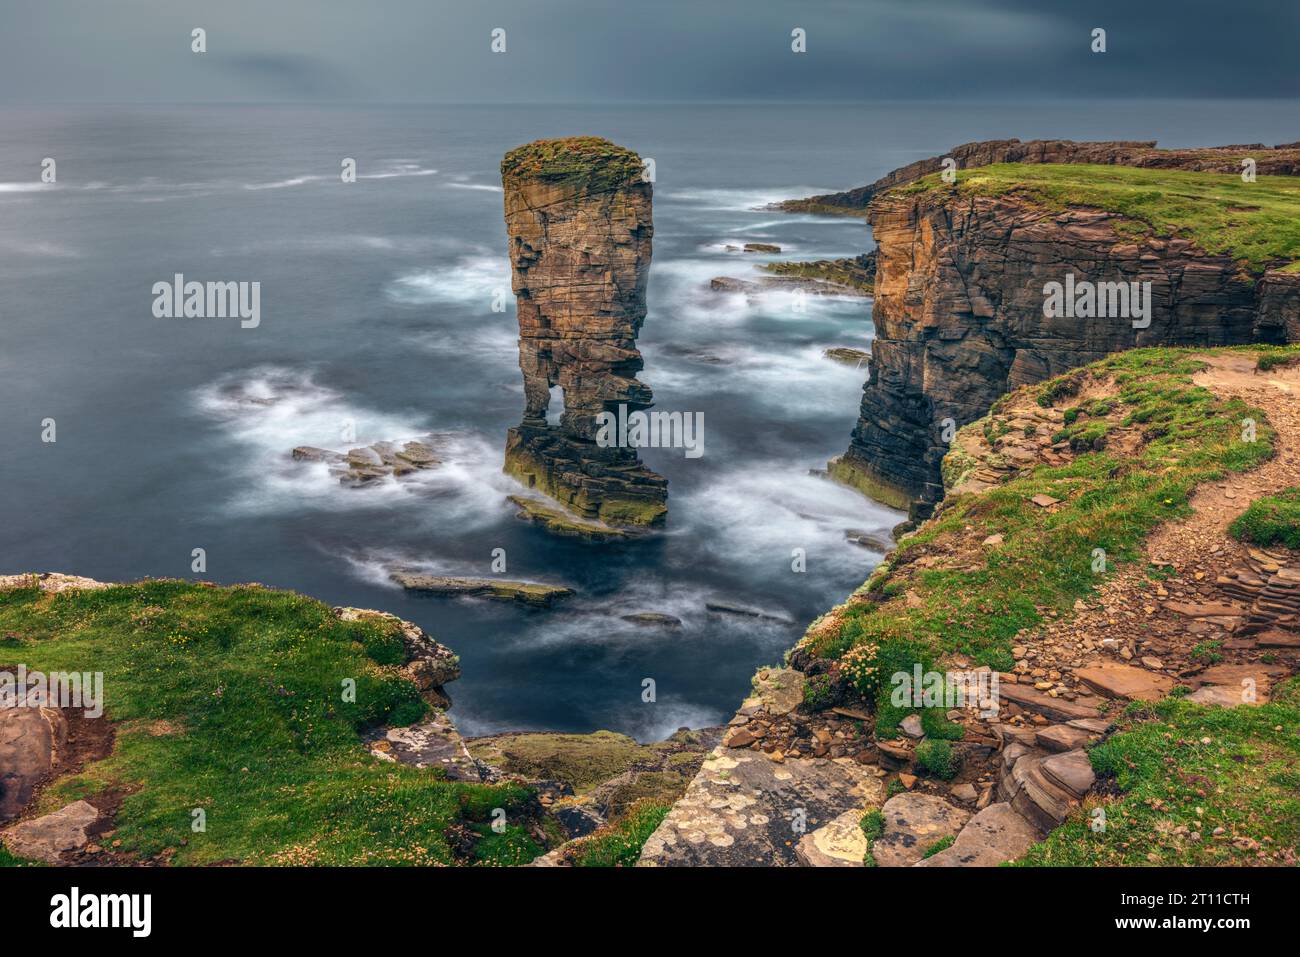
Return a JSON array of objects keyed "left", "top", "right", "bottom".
[{"left": 831, "top": 191, "right": 1300, "bottom": 515}]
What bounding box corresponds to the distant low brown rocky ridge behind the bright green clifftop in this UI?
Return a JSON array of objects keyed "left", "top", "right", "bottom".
[{"left": 780, "top": 139, "right": 1300, "bottom": 215}]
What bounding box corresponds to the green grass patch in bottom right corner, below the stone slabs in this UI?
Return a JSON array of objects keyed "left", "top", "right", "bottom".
[{"left": 1018, "top": 679, "right": 1300, "bottom": 867}]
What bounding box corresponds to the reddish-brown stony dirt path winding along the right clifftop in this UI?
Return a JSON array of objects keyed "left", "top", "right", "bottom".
[{"left": 1017, "top": 354, "right": 1300, "bottom": 692}]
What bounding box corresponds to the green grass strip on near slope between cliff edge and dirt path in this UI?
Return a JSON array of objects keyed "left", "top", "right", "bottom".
[{"left": 802, "top": 348, "right": 1274, "bottom": 681}]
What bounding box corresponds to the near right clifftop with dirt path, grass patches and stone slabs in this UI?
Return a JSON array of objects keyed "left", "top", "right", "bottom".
[{"left": 640, "top": 347, "right": 1300, "bottom": 867}]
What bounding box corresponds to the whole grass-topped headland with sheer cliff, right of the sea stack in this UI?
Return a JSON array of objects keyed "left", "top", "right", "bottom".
[{"left": 787, "top": 140, "right": 1300, "bottom": 516}]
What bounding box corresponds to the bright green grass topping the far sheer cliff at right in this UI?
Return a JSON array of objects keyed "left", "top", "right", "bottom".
[{"left": 900, "top": 162, "right": 1300, "bottom": 272}]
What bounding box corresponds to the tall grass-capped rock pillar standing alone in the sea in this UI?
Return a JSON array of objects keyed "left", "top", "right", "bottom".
[{"left": 501, "top": 137, "right": 668, "bottom": 527}]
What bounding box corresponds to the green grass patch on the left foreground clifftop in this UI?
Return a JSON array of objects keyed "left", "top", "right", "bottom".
[{"left": 0, "top": 581, "right": 532, "bottom": 865}]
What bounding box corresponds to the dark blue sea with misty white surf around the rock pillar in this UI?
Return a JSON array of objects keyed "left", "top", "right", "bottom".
[{"left": 0, "top": 101, "right": 1300, "bottom": 739}]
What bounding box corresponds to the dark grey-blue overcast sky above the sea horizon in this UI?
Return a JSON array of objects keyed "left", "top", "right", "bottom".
[{"left": 0, "top": 0, "right": 1300, "bottom": 104}]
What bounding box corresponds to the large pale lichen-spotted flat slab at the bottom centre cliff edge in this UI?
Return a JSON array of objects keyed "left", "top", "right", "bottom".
[{"left": 638, "top": 748, "right": 883, "bottom": 867}]
